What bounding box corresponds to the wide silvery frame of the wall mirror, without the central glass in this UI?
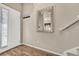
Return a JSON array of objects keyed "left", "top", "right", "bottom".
[{"left": 37, "top": 6, "right": 54, "bottom": 33}]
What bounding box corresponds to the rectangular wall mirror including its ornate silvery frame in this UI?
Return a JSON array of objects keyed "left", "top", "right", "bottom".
[{"left": 37, "top": 6, "right": 54, "bottom": 32}]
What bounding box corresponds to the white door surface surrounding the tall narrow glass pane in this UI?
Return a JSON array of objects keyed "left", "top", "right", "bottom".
[{"left": 0, "top": 4, "right": 20, "bottom": 53}]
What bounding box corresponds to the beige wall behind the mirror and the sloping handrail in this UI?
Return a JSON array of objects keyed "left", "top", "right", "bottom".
[{"left": 23, "top": 3, "right": 79, "bottom": 53}]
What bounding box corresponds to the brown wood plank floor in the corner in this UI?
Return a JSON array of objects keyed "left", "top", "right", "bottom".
[{"left": 0, "top": 45, "right": 57, "bottom": 56}]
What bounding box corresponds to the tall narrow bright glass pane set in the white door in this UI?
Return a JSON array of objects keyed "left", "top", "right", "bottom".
[{"left": 0, "top": 8, "right": 9, "bottom": 48}]
